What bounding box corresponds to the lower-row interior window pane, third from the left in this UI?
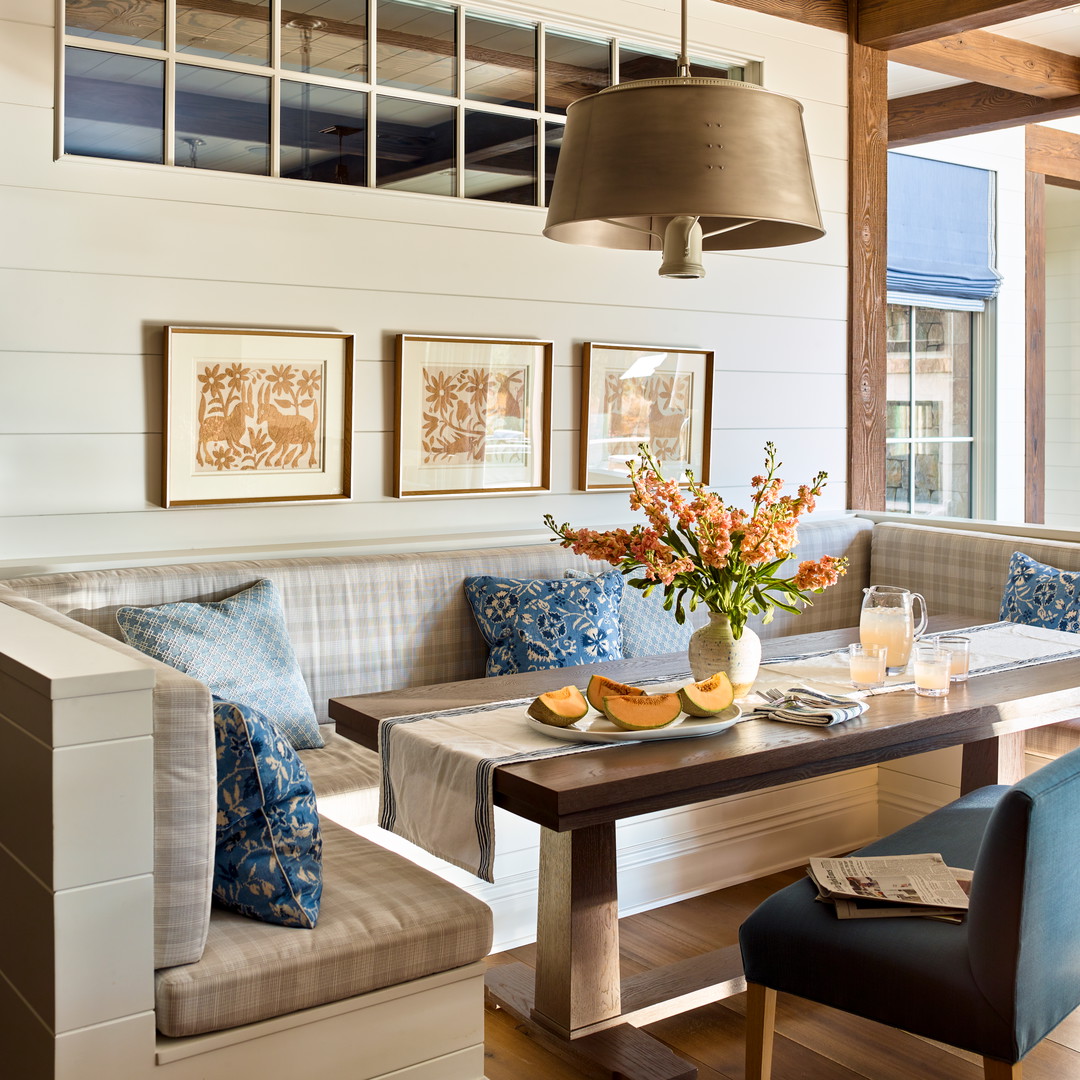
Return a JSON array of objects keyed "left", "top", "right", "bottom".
[{"left": 281, "top": 79, "right": 367, "bottom": 185}]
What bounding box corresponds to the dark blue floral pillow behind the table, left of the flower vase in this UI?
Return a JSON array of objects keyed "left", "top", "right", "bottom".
[{"left": 465, "top": 570, "right": 622, "bottom": 675}]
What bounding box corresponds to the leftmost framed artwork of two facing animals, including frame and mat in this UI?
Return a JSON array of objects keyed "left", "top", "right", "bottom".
[{"left": 162, "top": 326, "right": 353, "bottom": 507}]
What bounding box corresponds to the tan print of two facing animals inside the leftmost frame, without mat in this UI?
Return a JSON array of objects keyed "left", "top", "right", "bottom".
[{"left": 191, "top": 361, "right": 325, "bottom": 473}]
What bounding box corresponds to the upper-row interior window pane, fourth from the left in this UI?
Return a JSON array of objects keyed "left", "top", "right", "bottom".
[{"left": 375, "top": 0, "right": 457, "bottom": 94}]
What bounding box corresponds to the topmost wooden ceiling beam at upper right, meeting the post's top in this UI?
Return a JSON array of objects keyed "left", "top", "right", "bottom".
[{"left": 851, "top": 0, "right": 1076, "bottom": 49}]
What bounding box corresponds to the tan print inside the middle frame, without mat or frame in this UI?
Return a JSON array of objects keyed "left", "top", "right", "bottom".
[{"left": 420, "top": 364, "right": 529, "bottom": 465}]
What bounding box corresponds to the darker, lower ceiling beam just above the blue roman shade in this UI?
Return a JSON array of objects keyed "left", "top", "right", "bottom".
[{"left": 889, "top": 82, "right": 1080, "bottom": 147}]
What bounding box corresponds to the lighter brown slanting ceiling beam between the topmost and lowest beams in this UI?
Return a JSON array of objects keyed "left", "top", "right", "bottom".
[{"left": 889, "top": 30, "right": 1080, "bottom": 97}]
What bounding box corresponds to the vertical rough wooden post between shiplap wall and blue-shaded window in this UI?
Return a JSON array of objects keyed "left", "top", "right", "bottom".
[{"left": 848, "top": 11, "right": 888, "bottom": 510}]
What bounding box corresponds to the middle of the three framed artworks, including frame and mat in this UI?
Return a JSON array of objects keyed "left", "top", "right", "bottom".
[{"left": 394, "top": 334, "right": 552, "bottom": 498}]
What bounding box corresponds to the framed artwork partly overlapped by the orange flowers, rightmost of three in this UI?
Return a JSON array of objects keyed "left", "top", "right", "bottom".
[{"left": 579, "top": 342, "right": 713, "bottom": 491}]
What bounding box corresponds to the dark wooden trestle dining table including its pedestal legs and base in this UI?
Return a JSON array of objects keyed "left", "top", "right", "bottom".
[{"left": 329, "top": 616, "right": 1080, "bottom": 1080}]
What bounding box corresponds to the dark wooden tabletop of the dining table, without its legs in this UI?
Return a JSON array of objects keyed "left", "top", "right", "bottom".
[{"left": 329, "top": 616, "right": 1080, "bottom": 832}]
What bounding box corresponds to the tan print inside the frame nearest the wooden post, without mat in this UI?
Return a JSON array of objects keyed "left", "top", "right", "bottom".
[{"left": 604, "top": 372, "right": 693, "bottom": 462}]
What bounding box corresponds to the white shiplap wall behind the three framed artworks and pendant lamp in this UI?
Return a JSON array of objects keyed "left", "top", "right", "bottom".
[{"left": 0, "top": 0, "right": 847, "bottom": 577}]
